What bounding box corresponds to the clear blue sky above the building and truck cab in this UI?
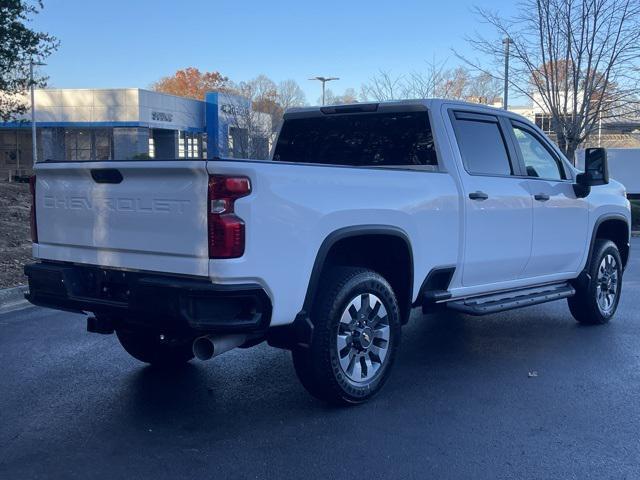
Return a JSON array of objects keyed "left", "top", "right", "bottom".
[{"left": 33, "top": 0, "right": 516, "bottom": 103}]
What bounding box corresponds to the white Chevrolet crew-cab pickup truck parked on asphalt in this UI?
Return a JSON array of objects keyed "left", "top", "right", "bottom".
[{"left": 25, "top": 100, "right": 630, "bottom": 403}]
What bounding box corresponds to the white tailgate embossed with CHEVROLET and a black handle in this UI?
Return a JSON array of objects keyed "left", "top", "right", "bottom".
[{"left": 34, "top": 160, "right": 209, "bottom": 276}]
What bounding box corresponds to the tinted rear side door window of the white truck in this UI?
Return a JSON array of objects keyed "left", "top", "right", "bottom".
[{"left": 455, "top": 112, "right": 513, "bottom": 176}]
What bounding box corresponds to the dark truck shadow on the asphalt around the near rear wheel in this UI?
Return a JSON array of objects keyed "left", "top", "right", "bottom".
[{"left": 112, "top": 305, "right": 615, "bottom": 436}]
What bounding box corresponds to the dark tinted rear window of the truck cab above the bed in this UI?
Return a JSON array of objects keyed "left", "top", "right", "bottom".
[{"left": 273, "top": 111, "right": 438, "bottom": 171}]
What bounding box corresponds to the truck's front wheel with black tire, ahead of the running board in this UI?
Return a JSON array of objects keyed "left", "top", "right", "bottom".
[{"left": 567, "top": 239, "right": 622, "bottom": 325}]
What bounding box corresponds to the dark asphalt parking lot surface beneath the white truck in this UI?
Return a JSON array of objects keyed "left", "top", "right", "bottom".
[{"left": 0, "top": 239, "right": 640, "bottom": 479}]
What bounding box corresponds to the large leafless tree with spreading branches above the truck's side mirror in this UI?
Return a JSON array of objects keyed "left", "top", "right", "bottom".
[{"left": 459, "top": 0, "right": 640, "bottom": 159}]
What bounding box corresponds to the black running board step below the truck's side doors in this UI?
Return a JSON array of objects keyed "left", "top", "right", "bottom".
[{"left": 447, "top": 283, "right": 576, "bottom": 315}]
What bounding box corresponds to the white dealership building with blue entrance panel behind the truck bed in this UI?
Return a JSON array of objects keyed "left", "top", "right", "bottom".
[{"left": 0, "top": 88, "right": 271, "bottom": 177}]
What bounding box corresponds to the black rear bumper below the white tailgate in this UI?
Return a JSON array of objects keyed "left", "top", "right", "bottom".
[{"left": 25, "top": 262, "right": 271, "bottom": 333}]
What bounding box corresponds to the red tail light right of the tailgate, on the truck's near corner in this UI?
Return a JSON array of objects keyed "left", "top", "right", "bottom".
[{"left": 207, "top": 175, "right": 251, "bottom": 258}]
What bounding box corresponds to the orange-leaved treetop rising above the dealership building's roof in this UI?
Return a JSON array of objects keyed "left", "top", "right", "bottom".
[{"left": 151, "top": 67, "right": 229, "bottom": 100}]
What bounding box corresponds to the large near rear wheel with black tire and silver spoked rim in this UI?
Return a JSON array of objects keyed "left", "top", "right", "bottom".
[{"left": 292, "top": 267, "right": 400, "bottom": 405}]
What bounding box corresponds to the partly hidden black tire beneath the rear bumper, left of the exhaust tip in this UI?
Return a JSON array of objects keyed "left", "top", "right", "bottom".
[{"left": 116, "top": 329, "right": 193, "bottom": 367}]
